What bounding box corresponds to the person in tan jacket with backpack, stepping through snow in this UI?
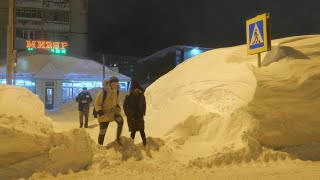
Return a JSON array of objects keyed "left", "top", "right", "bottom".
[{"left": 94, "top": 77, "right": 123, "bottom": 145}]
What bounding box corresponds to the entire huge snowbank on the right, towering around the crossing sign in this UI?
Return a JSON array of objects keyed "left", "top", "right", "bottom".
[{"left": 146, "top": 36, "right": 320, "bottom": 166}]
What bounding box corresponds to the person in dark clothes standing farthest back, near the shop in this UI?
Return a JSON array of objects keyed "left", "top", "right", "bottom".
[{"left": 76, "top": 87, "right": 92, "bottom": 128}]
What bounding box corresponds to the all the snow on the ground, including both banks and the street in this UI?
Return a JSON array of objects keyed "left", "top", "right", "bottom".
[{"left": 0, "top": 35, "right": 320, "bottom": 180}]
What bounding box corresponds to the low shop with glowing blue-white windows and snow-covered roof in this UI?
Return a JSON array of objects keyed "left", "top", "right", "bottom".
[{"left": 0, "top": 52, "right": 131, "bottom": 109}]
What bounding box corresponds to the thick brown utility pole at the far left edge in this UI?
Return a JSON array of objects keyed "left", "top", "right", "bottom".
[{"left": 7, "top": 0, "right": 15, "bottom": 84}]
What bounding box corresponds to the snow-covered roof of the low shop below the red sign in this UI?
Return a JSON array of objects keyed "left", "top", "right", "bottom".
[{"left": 0, "top": 53, "right": 131, "bottom": 81}]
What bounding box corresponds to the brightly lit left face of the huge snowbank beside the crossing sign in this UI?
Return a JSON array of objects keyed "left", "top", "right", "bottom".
[{"left": 146, "top": 47, "right": 256, "bottom": 162}]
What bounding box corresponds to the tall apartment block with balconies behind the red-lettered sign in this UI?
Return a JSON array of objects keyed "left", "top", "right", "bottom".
[{"left": 0, "top": 0, "right": 88, "bottom": 63}]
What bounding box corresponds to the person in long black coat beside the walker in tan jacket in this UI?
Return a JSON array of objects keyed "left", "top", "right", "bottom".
[{"left": 123, "top": 81, "right": 147, "bottom": 146}]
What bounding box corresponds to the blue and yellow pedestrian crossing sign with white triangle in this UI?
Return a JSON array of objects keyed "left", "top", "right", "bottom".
[{"left": 246, "top": 13, "right": 271, "bottom": 54}]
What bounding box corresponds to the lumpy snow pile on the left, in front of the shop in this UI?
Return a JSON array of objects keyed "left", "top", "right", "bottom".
[{"left": 0, "top": 85, "right": 93, "bottom": 179}]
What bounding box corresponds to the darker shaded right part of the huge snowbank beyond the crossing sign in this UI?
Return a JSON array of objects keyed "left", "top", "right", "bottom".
[{"left": 248, "top": 37, "right": 320, "bottom": 148}]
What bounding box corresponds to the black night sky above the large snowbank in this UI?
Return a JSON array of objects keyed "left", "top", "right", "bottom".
[{"left": 89, "top": 0, "right": 320, "bottom": 57}]
